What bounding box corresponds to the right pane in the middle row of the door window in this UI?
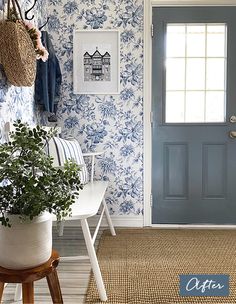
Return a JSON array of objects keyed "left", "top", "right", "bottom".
[{"left": 206, "top": 58, "right": 225, "bottom": 90}]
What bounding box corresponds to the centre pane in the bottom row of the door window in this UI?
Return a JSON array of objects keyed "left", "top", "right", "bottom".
[{"left": 185, "top": 92, "right": 205, "bottom": 122}]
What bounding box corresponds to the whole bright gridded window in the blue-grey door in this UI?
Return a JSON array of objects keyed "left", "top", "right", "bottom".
[{"left": 165, "top": 23, "right": 227, "bottom": 123}]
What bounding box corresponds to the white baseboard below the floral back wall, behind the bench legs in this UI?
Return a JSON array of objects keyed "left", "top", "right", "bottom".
[{"left": 54, "top": 216, "right": 143, "bottom": 227}]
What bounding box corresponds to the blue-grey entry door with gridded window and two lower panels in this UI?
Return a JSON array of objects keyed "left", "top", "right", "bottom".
[{"left": 152, "top": 7, "right": 236, "bottom": 224}]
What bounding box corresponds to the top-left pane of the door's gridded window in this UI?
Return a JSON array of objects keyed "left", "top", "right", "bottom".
[{"left": 166, "top": 25, "right": 185, "bottom": 57}]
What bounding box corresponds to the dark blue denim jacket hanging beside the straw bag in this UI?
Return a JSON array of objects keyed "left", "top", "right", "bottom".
[{"left": 35, "top": 31, "right": 62, "bottom": 120}]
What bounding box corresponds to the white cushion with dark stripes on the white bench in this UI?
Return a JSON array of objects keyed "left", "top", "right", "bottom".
[{"left": 47, "top": 137, "right": 88, "bottom": 184}]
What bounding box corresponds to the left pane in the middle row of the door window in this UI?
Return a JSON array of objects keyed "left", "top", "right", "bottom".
[{"left": 166, "top": 59, "right": 185, "bottom": 91}]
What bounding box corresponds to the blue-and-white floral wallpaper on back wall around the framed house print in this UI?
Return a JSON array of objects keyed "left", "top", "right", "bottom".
[{"left": 48, "top": 0, "right": 143, "bottom": 216}]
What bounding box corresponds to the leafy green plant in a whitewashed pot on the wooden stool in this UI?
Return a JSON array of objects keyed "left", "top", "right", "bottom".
[{"left": 0, "top": 121, "right": 82, "bottom": 269}]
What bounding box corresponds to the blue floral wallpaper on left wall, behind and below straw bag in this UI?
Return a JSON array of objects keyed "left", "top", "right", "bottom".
[{"left": 0, "top": 0, "right": 45, "bottom": 142}]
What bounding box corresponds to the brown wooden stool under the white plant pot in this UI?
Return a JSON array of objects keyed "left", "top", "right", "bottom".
[{"left": 0, "top": 250, "right": 63, "bottom": 304}]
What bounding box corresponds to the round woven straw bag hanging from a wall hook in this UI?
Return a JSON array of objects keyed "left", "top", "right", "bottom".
[{"left": 0, "top": 0, "right": 36, "bottom": 87}]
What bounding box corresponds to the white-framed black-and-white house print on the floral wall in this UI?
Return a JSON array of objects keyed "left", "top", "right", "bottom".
[{"left": 73, "top": 29, "right": 120, "bottom": 95}]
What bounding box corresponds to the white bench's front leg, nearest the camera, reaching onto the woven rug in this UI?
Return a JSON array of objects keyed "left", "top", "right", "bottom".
[{"left": 81, "top": 219, "right": 107, "bottom": 301}]
